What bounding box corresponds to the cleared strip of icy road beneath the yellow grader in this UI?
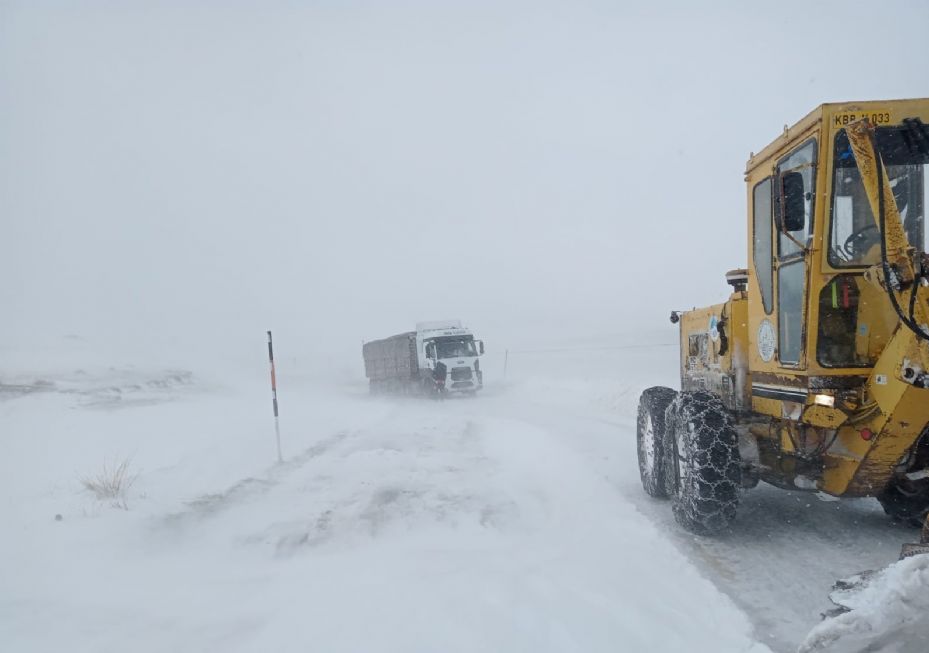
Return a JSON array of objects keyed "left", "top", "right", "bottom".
[{"left": 478, "top": 384, "right": 919, "bottom": 652}]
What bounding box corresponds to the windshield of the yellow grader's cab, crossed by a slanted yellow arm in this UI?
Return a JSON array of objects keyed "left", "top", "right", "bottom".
[{"left": 829, "top": 122, "right": 929, "bottom": 267}]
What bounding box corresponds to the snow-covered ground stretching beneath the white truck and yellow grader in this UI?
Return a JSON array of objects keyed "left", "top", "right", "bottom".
[{"left": 0, "top": 347, "right": 914, "bottom": 653}]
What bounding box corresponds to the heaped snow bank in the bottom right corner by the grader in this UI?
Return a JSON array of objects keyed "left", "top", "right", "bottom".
[{"left": 800, "top": 554, "right": 929, "bottom": 653}]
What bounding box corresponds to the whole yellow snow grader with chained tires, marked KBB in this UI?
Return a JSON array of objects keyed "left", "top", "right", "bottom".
[{"left": 637, "top": 99, "right": 929, "bottom": 554}]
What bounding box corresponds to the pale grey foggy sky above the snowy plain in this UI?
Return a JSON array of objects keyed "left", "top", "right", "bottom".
[{"left": 0, "top": 0, "right": 929, "bottom": 366}]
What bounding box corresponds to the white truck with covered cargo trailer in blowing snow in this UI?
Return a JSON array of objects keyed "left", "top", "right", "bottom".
[{"left": 362, "top": 320, "right": 484, "bottom": 396}]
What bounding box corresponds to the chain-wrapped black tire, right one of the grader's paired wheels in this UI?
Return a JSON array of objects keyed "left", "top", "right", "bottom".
[{"left": 664, "top": 392, "right": 742, "bottom": 535}]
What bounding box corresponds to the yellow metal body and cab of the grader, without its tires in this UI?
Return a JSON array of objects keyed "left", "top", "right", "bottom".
[{"left": 680, "top": 99, "right": 929, "bottom": 496}]
